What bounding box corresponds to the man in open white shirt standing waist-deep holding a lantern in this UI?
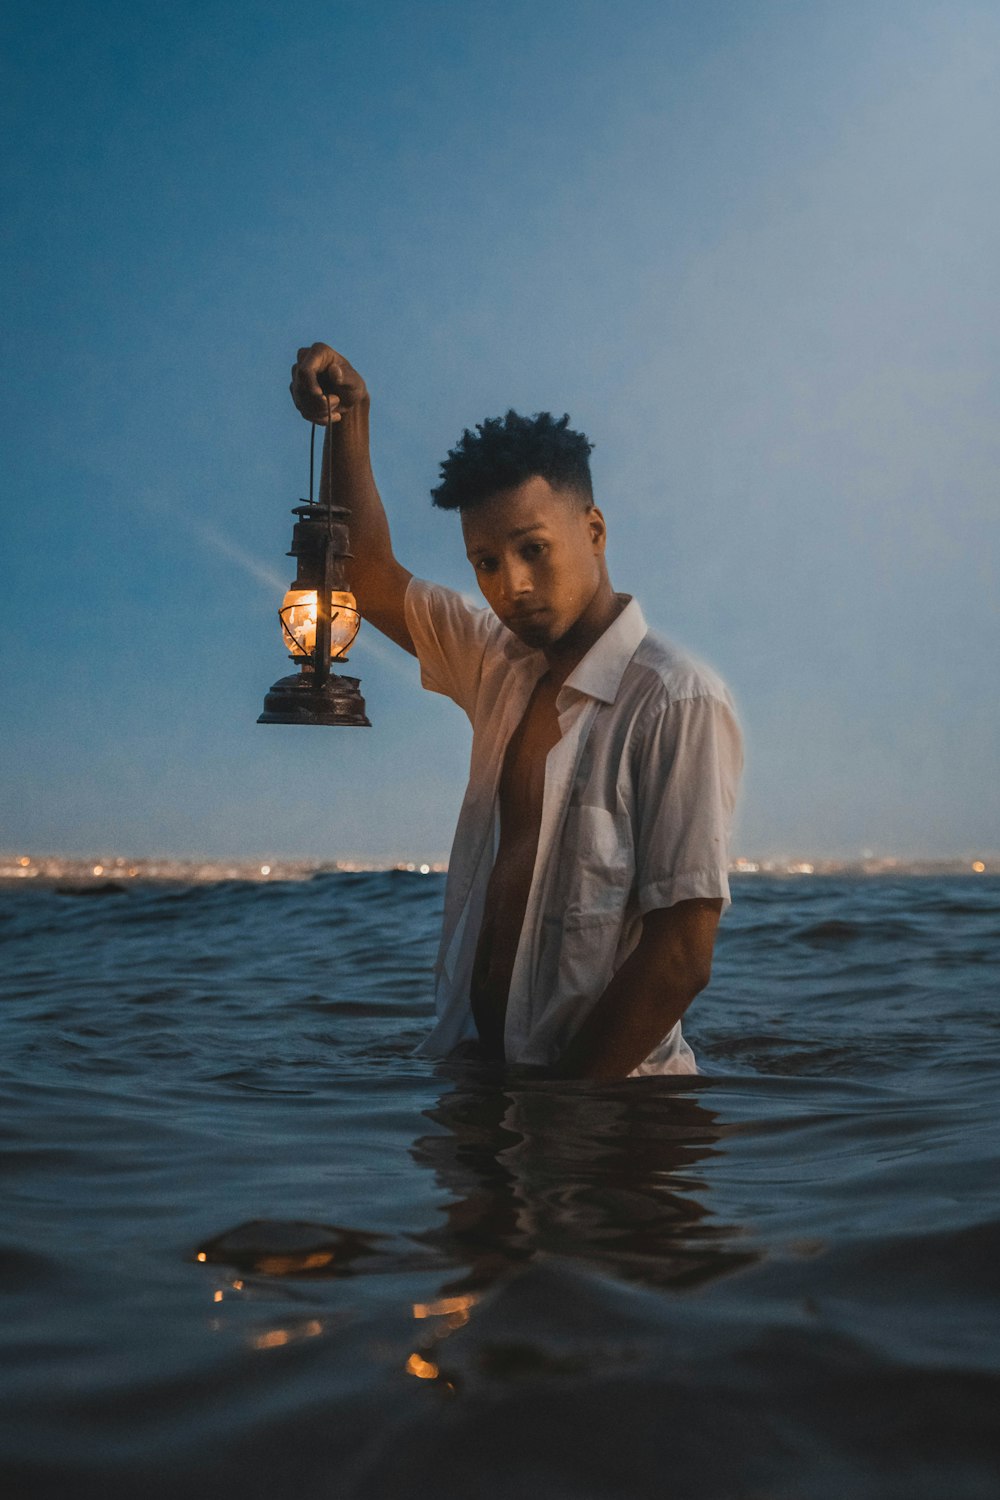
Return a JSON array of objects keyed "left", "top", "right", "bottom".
[{"left": 291, "top": 344, "right": 742, "bottom": 1079}]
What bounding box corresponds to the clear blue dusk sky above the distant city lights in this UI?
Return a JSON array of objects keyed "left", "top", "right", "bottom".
[{"left": 0, "top": 0, "right": 1000, "bottom": 858}]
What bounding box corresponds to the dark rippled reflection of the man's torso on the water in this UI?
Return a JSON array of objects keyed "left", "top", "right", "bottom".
[{"left": 412, "top": 1073, "right": 757, "bottom": 1296}]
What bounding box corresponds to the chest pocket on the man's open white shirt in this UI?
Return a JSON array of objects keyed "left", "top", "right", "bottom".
[{"left": 552, "top": 804, "right": 636, "bottom": 927}]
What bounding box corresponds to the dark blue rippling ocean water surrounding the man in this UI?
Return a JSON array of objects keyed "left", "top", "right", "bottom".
[{"left": 0, "top": 873, "right": 1000, "bottom": 1500}]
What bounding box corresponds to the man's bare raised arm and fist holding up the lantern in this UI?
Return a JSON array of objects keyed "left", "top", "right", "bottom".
[{"left": 291, "top": 344, "right": 415, "bottom": 656}]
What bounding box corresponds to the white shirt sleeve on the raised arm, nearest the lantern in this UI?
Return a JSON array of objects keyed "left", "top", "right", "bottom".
[{"left": 403, "top": 578, "right": 502, "bottom": 719}]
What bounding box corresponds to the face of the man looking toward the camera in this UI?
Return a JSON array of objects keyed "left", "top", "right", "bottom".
[{"left": 462, "top": 476, "right": 606, "bottom": 650}]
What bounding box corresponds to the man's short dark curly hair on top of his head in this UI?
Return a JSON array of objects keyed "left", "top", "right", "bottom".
[{"left": 430, "top": 411, "right": 594, "bottom": 510}]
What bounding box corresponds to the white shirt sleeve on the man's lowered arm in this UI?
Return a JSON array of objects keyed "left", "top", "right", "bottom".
[{"left": 634, "top": 695, "right": 744, "bottom": 915}]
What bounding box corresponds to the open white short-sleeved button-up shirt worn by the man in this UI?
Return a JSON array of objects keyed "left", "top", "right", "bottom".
[{"left": 406, "top": 579, "right": 742, "bottom": 1076}]
